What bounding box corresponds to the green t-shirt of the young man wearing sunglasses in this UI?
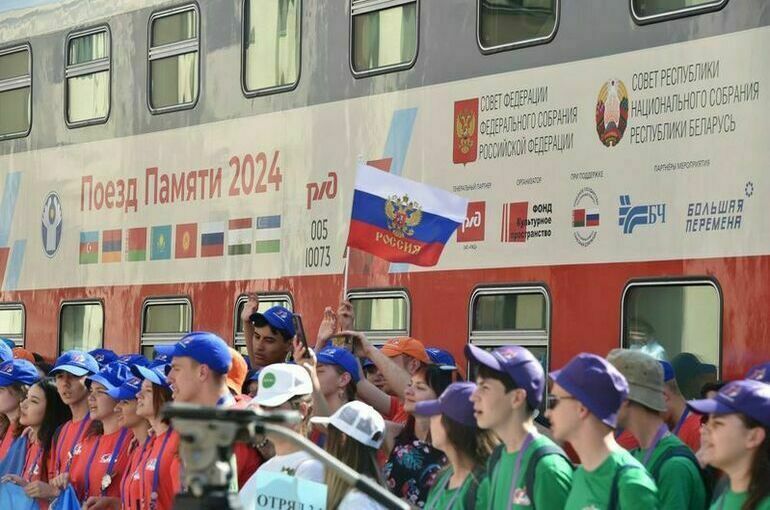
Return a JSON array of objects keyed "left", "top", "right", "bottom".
[{"left": 564, "top": 450, "right": 660, "bottom": 510}]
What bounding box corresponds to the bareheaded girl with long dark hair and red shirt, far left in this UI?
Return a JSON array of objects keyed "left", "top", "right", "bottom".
[{"left": 3, "top": 378, "right": 72, "bottom": 509}]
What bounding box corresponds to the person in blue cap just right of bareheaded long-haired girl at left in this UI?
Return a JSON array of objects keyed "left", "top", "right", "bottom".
[{"left": 49, "top": 351, "right": 99, "bottom": 488}]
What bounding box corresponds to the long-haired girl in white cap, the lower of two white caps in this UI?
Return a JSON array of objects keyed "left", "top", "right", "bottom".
[{"left": 310, "top": 400, "right": 385, "bottom": 510}]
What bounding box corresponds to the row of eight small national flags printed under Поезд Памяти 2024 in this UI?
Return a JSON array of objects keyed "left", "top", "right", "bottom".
[{"left": 80, "top": 215, "right": 281, "bottom": 264}]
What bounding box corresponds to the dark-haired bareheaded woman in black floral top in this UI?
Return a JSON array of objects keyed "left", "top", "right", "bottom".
[{"left": 384, "top": 365, "right": 452, "bottom": 508}]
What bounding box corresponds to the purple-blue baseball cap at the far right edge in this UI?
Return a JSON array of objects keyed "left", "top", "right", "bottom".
[{"left": 687, "top": 379, "right": 770, "bottom": 427}]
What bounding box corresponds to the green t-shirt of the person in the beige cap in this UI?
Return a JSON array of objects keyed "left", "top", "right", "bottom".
[{"left": 631, "top": 434, "right": 706, "bottom": 510}]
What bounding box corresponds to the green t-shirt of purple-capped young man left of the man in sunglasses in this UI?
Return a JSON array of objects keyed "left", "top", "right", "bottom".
[{"left": 476, "top": 436, "right": 573, "bottom": 510}]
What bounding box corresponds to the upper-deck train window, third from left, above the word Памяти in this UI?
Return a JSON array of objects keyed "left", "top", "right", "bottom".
[{"left": 148, "top": 5, "right": 200, "bottom": 113}]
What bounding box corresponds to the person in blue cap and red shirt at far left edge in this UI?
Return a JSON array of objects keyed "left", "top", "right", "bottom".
[{"left": 0, "top": 359, "right": 40, "bottom": 459}]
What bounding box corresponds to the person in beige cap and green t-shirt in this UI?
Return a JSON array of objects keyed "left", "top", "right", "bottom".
[{"left": 607, "top": 349, "right": 706, "bottom": 510}]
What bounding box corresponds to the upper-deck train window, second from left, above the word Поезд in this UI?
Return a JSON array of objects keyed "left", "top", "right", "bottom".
[{"left": 64, "top": 27, "right": 111, "bottom": 127}]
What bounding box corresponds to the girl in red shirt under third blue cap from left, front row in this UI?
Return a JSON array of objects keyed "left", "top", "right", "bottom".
[{"left": 51, "top": 361, "right": 131, "bottom": 501}]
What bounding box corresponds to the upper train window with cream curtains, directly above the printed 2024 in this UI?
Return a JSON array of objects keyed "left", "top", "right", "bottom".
[{"left": 242, "top": 0, "right": 302, "bottom": 95}]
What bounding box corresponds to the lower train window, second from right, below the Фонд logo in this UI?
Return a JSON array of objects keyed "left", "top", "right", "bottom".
[{"left": 469, "top": 286, "right": 551, "bottom": 370}]
